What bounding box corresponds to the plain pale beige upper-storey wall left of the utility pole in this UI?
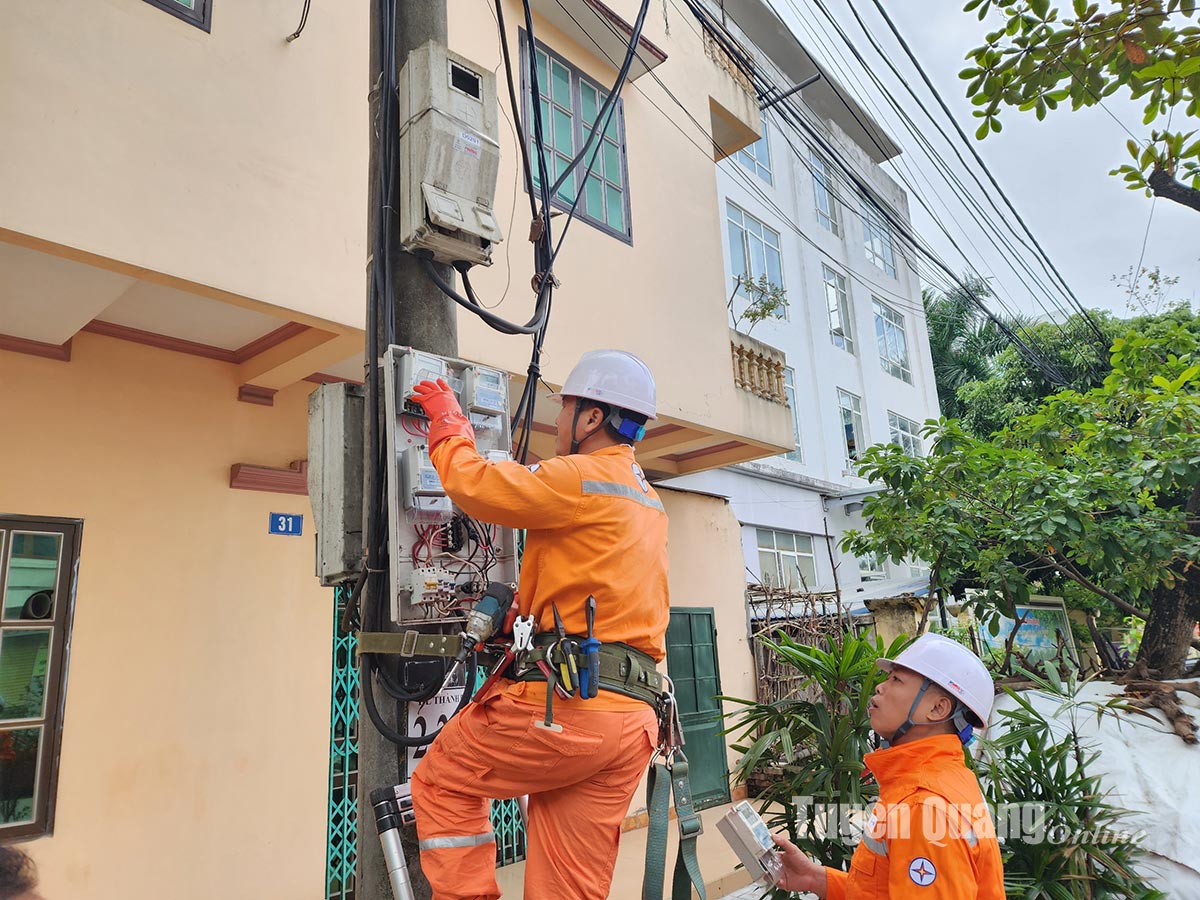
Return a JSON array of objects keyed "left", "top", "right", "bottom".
[{"left": 0, "top": 0, "right": 368, "bottom": 331}]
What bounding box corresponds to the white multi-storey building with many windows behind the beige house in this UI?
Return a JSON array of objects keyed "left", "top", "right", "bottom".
[{"left": 679, "top": 0, "right": 938, "bottom": 608}]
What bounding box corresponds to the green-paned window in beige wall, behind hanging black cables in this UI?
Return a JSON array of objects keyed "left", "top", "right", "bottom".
[{"left": 521, "top": 32, "right": 632, "bottom": 241}]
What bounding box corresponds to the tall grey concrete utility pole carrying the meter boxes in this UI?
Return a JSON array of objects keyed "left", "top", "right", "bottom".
[{"left": 355, "top": 0, "right": 458, "bottom": 900}]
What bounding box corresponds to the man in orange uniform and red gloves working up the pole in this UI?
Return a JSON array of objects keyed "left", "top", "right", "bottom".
[{"left": 412, "top": 350, "right": 670, "bottom": 900}]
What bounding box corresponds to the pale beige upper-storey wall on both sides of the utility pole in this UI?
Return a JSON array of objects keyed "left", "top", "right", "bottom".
[{"left": 0, "top": 0, "right": 790, "bottom": 455}]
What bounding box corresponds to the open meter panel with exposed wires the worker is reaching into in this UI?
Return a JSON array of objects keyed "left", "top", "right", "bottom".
[{"left": 382, "top": 347, "right": 517, "bottom": 623}]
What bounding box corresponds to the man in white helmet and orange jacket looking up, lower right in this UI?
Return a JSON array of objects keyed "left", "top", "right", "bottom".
[{"left": 775, "top": 635, "right": 1004, "bottom": 900}]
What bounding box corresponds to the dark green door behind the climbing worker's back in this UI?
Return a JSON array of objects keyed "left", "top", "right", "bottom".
[{"left": 667, "top": 607, "right": 730, "bottom": 809}]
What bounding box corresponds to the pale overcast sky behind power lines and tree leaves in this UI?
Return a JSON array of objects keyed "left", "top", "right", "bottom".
[{"left": 775, "top": 0, "right": 1200, "bottom": 313}]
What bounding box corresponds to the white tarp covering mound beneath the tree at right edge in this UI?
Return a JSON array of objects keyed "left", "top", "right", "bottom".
[{"left": 991, "top": 682, "right": 1200, "bottom": 900}]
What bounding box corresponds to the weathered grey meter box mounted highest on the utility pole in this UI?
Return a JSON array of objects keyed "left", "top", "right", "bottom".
[{"left": 397, "top": 41, "right": 503, "bottom": 265}]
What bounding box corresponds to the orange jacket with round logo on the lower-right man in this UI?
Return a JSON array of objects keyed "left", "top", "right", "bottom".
[{"left": 826, "top": 734, "right": 1004, "bottom": 900}]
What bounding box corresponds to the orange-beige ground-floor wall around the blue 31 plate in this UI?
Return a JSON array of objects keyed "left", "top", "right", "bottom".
[{"left": 0, "top": 334, "right": 332, "bottom": 900}]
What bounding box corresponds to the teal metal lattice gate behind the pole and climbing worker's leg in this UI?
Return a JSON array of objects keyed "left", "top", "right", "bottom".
[{"left": 325, "top": 586, "right": 526, "bottom": 900}]
